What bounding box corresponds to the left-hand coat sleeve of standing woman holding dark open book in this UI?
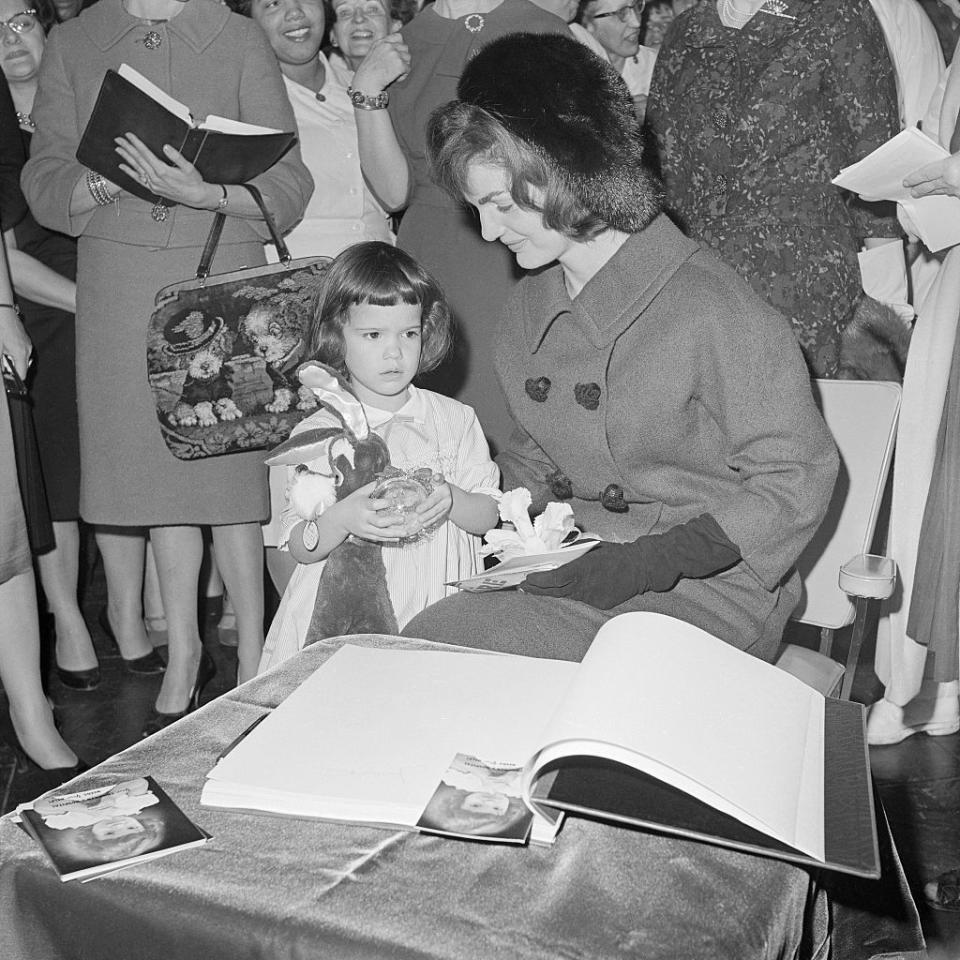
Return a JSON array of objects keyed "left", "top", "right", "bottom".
[{"left": 20, "top": 28, "right": 94, "bottom": 237}]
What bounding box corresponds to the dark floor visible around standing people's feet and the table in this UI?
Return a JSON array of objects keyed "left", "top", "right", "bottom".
[{"left": 0, "top": 536, "right": 960, "bottom": 960}]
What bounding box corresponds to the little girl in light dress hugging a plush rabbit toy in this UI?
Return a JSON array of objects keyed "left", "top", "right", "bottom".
[{"left": 260, "top": 241, "right": 500, "bottom": 672}]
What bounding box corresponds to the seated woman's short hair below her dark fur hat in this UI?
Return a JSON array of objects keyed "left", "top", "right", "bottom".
[{"left": 427, "top": 100, "right": 609, "bottom": 241}]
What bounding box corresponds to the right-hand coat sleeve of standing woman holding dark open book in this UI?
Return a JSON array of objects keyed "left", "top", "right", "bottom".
[{"left": 240, "top": 21, "right": 313, "bottom": 239}]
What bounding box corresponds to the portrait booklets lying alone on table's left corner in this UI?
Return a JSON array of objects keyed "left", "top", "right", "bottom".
[{"left": 16, "top": 777, "right": 210, "bottom": 880}]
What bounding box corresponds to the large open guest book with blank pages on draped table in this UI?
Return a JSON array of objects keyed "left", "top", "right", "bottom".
[{"left": 201, "top": 613, "right": 878, "bottom": 876}]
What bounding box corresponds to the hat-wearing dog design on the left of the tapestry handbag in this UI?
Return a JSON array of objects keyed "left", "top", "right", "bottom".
[{"left": 165, "top": 310, "right": 241, "bottom": 427}]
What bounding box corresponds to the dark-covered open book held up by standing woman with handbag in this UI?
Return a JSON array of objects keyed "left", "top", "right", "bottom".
[{"left": 77, "top": 63, "right": 297, "bottom": 202}]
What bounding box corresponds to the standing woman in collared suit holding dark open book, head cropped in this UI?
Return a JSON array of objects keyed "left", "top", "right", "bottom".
[{"left": 23, "top": 0, "right": 313, "bottom": 733}]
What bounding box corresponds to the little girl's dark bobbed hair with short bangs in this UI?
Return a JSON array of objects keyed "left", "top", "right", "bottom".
[{"left": 310, "top": 240, "right": 453, "bottom": 374}]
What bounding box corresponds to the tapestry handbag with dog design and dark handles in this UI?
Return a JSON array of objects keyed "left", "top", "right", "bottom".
[{"left": 147, "top": 184, "right": 330, "bottom": 460}]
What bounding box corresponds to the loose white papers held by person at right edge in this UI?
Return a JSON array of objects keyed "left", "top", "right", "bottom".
[{"left": 832, "top": 127, "right": 960, "bottom": 253}]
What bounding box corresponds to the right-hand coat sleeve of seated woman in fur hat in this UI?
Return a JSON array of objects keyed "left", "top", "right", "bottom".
[{"left": 693, "top": 268, "right": 839, "bottom": 590}]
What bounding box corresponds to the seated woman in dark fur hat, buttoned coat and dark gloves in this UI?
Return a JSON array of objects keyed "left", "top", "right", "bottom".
[{"left": 404, "top": 34, "right": 837, "bottom": 660}]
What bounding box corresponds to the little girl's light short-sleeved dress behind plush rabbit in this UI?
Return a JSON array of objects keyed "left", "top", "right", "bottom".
[{"left": 259, "top": 386, "right": 500, "bottom": 673}]
